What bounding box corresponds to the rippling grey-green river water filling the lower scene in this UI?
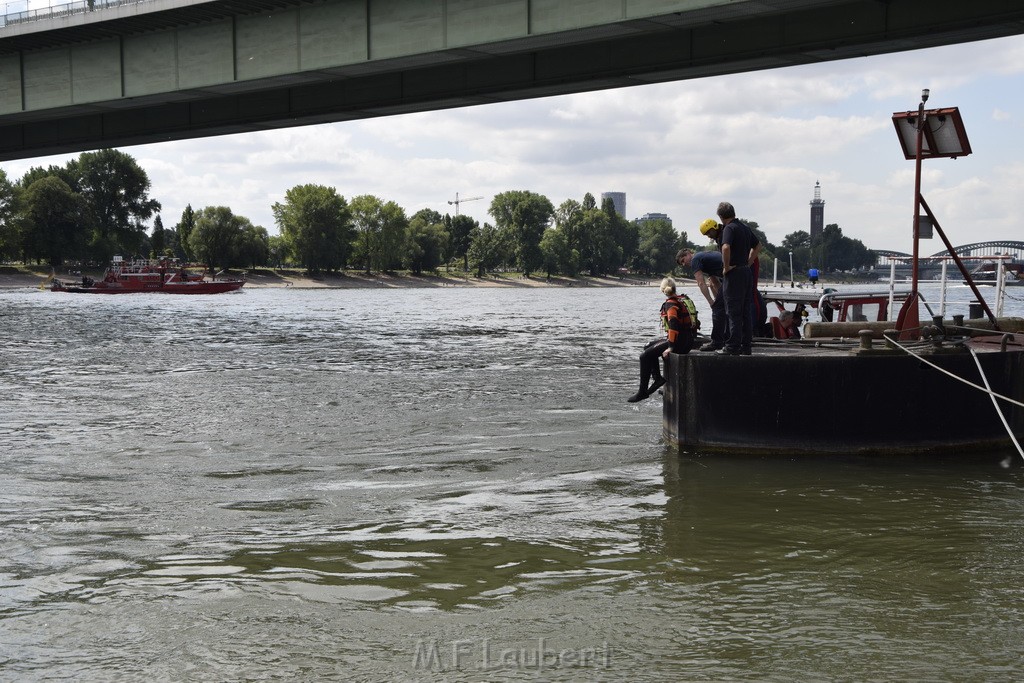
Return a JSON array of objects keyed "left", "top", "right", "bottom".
[{"left": 0, "top": 287, "right": 1024, "bottom": 681}]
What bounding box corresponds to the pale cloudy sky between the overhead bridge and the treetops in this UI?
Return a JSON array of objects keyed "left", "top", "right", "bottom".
[{"left": 0, "top": 29, "right": 1024, "bottom": 254}]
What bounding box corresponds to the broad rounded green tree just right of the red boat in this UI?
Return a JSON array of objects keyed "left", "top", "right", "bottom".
[{"left": 268, "top": 184, "right": 352, "bottom": 273}]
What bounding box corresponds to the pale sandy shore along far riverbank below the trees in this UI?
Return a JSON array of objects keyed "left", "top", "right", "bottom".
[{"left": 0, "top": 266, "right": 659, "bottom": 289}]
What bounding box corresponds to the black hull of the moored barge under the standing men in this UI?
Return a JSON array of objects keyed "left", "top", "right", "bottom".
[{"left": 664, "top": 347, "right": 1024, "bottom": 456}]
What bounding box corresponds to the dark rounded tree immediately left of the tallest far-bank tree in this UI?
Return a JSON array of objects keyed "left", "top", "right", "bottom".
[{"left": 25, "top": 175, "right": 86, "bottom": 266}]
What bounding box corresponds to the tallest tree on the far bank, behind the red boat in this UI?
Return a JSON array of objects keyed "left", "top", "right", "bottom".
[{"left": 68, "top": 150, "right": 160, "bottom": 261}]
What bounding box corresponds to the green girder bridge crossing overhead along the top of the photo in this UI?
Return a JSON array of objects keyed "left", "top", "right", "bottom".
[{"left": 0, "top": 0, "right": 1024, "bottom": 160}]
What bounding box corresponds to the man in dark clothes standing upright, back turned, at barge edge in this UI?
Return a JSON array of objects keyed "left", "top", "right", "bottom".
[{"left": 717, "top": 202, "right": 761, "bottom": 355}]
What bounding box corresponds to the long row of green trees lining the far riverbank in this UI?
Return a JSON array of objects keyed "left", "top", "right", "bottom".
[{"left": 0, "top": 150, "right": 874, "bottom": 276}]
